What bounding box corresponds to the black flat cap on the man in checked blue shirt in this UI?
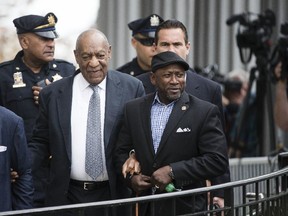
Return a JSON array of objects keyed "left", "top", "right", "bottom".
[{"left": 152, "top": 51, "right": 189, "bottom": 72}]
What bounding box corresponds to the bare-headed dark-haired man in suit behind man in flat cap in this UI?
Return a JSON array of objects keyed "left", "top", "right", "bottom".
[{"left": 123, "top": 19, "right": 232, "bottom": 207}]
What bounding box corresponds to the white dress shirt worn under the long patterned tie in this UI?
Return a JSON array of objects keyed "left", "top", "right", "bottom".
[{"left": 70, "top": 73, "right": 108, "bottom": 181}]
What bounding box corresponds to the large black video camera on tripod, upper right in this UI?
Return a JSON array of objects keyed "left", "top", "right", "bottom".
[{"left": 226, "top": 9, "right": 275, "bottom": 63}]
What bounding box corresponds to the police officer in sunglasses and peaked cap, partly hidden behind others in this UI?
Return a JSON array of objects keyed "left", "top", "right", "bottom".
[{"left": 117, "top": 14, "right": 164, "bottom": 76}]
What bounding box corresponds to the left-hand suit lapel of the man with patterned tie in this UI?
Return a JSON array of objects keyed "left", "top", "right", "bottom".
[{"left": 56, "top": 76, "right": 74, "bottom": 161}]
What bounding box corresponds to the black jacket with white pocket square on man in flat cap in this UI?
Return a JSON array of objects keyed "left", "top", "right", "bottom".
[{"left": 115, "top": 92, "right": 228, "bottom": 215}]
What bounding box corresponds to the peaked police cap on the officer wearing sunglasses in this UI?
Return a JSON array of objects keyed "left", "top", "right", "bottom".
[{"left": 128, "top": 14, "right": 164, "bottom": 38}]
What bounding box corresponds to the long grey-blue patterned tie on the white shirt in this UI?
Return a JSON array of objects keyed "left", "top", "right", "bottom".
[{"left": 85, "top": 85, "right": 103, "bottom": 181}]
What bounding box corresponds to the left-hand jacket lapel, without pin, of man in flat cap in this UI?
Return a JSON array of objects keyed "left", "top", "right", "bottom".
[{"left": 141, "top": 94, "right": 155, "bottom": 156}]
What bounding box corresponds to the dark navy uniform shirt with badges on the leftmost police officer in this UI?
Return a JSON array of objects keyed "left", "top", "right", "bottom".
[{"left": 0, "top": 51, "right": 75, "bottom": 141}]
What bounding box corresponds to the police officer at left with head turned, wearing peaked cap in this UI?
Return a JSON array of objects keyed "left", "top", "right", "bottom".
[{"left": 0, "top": 13, "right": 75, "bottom": 208}]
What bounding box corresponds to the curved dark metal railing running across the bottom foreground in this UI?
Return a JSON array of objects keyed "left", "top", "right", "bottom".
[{"left": 0, "top": 168, "right": 288, "bottom": 216}]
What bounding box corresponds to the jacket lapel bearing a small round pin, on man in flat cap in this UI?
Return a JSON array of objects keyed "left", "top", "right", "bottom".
[{"left": 157, "top": 92, "right": 189, "bottom": 155}]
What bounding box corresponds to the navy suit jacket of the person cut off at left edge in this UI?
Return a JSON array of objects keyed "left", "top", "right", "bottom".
[{"left": 0, "top": 106, "right": 34, "bottom": 212}]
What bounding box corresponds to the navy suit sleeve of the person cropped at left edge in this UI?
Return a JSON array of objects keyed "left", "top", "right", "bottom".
[{"left": 11, "top": 120, "right": 34, "bottom": 210}]
